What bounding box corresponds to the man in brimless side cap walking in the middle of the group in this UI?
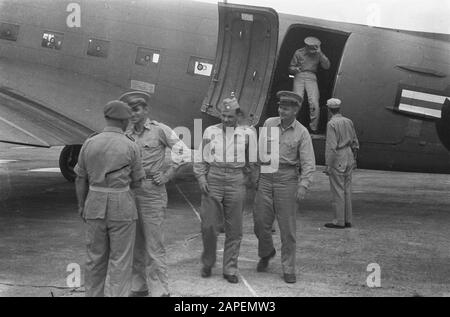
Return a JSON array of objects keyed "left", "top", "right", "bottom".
[{"left": 194, "top": 97, "right": 257, "bottom": 283}]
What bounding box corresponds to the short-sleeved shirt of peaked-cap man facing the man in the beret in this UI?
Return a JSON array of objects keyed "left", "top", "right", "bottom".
[{"left": 126, "top": 119, "right": 190, "bottom": 175}]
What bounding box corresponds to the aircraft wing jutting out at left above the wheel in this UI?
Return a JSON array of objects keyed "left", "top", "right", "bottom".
[{"left": 0, "top": 86, "right": 94, "bottom": 147}]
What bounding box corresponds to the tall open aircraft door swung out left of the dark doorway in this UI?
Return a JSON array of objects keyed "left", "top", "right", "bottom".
[{"left": 201, "top": 3, "right": 278, "bottom": 125}]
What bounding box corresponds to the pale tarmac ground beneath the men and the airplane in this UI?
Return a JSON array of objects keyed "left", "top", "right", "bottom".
[{"left": 0, "top": 144, "right": 450, "bottom": 297}]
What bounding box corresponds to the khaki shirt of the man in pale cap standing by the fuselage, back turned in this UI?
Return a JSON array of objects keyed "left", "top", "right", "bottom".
[{"left": 325, "top": 114, "right": 359, "bottom": 172}]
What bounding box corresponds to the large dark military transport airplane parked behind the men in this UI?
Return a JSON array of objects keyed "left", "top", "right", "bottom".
[{"left": 0, "top": 0, "right": 450, "bottom": 181}]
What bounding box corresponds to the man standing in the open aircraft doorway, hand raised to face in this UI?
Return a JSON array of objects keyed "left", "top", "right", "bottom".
[{"left": 289, "top": 36, "right": 330, "bottom": 133}]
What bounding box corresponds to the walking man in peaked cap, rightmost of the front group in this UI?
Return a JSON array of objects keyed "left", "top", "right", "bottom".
[{"left": 253, "top": 91, "right": 315, "bottom": 283}]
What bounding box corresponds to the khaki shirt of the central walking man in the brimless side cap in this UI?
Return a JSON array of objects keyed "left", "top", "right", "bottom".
[{"left": 194, "top": 123, "right": 258, "bottom": 180}]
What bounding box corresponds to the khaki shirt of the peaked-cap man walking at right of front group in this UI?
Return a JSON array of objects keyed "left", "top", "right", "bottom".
[{"left": 259, "top": 117, "right": 316, "bottom": 188}]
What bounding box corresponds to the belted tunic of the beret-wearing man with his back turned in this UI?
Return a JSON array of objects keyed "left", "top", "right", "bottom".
[{"left": 75, "top": 127, "right": 145, "bottom": 221}]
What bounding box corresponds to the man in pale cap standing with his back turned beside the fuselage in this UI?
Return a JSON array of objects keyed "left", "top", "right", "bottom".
[{"left": 325, "top": 98, "right": 359, "bottom": 229}]
